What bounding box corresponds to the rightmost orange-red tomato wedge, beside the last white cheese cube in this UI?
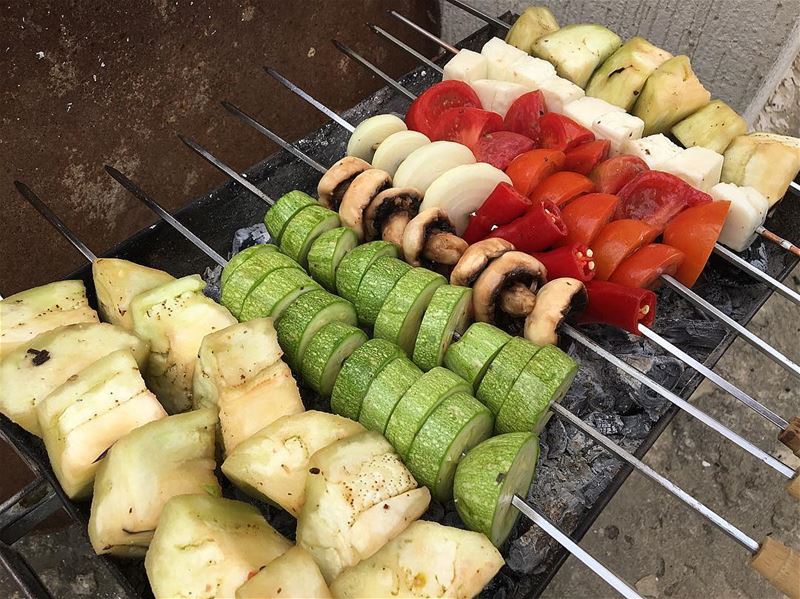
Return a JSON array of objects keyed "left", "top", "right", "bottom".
[{"left": 664, "top": 201, "right": 731, "bottom": 287}]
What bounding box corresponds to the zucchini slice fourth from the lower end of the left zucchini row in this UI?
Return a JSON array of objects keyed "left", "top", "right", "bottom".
[{"left": 358, "top": 356, "right": 422, "bottom": 434}]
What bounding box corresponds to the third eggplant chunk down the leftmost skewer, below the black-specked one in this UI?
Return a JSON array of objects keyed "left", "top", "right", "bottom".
[{"left": 36, "top": 349, "right": 167, "bottom": 499}]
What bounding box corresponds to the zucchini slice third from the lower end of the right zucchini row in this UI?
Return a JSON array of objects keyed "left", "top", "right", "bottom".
[{"left": 444, "top": 322, "right": 511, "bottom": 392}]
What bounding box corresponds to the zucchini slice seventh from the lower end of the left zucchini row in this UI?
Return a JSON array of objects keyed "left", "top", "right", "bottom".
[{"left": 276, "top": 289, "right": 358, "bottom": 370}]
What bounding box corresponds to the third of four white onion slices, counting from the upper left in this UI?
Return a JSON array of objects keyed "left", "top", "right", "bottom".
[{"left": 393, "top": 141, "right": 475, "bottom": 194}]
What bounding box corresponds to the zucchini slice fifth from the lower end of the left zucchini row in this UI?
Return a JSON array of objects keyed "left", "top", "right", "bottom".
[{"left": 331, "top": 339, "right": 403, "bottom": 420}]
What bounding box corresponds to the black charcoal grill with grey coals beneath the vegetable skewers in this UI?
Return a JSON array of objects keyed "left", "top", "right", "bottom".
[{"left": 0, "top": 5, "right": 800, "bottom": 597}]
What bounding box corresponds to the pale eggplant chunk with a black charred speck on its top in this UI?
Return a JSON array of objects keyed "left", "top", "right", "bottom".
[{"left": 0, "top": 323, "right": 149, "bottom": 436}]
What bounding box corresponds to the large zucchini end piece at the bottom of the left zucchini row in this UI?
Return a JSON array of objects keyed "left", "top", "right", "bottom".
[{"left": 453, "top": 433, "right": 539, "bottom": 547}]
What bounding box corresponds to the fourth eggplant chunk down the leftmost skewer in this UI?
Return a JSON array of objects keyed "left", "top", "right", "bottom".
[{"left": 89, "top": 410, "right": 222, "bottom": 557}]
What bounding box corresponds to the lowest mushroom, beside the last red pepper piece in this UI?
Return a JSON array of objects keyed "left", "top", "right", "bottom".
[{"left": 525, "top": 277, "right": 589, "bottom": 345}]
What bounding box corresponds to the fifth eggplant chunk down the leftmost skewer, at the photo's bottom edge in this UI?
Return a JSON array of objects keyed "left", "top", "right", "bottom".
[{"left": 144, "top": 495, "right": 292, "bottom": 599}]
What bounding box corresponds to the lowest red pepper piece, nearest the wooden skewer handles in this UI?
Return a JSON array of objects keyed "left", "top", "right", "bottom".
[{"left": 578, "top": 279, "right": 656, "bottom": 335}]
